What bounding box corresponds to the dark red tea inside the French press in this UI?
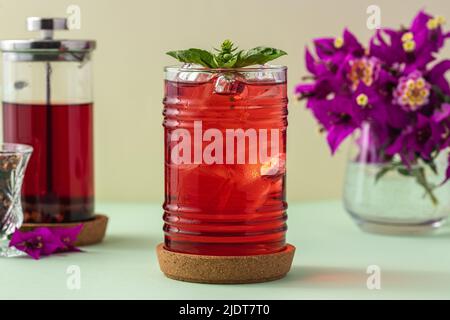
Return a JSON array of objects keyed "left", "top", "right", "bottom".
[{"left": 3, "top": 102, "right": 94, "bottom": 222}]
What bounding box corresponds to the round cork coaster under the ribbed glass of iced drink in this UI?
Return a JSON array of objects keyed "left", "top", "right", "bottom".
[{"left": 156, "top": 243, "right": 295, "bottom": 284}]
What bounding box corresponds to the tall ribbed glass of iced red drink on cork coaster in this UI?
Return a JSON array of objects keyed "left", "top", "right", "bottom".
[{"left": 163, "top": 65, "right": 288, "bottom": 256}]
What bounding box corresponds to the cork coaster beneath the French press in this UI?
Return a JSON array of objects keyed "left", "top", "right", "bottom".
[{"left": 20, "top": 214, "right": 108, "bottom": 247}]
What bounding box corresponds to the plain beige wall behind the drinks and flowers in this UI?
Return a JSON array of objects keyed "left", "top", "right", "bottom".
[{"left": 0, "top": 0, "right": 450, "bottom": 202}]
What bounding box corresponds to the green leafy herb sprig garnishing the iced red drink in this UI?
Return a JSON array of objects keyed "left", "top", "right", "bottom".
[{"left": 167, "top": 40, "right": 287, "bottom": 69}]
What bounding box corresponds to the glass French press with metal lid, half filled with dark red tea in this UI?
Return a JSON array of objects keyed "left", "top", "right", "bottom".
[{"left": 1, "top": 17, "right": 95, "bottom": 223}]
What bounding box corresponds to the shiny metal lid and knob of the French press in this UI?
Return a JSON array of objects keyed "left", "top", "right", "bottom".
[{"left": 0, "top": 17, "right": 96, "bottom": 60}]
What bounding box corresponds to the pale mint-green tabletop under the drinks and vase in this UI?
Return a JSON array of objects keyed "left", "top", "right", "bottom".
[{"left": 0, "top": 201, "right": 450, "bottom": 299}]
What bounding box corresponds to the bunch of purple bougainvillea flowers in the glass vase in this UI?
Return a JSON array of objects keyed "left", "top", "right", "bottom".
[{"left": 296, "top": 11, "right": 450, "bottom": 202}]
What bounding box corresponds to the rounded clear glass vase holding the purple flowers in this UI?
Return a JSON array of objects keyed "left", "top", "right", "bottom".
[{"left": 344, "top": 124, "right": 450, "bottom": 234}]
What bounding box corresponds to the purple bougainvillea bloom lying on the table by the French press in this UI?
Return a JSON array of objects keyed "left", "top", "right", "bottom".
[{"left": 9, "top": 228, "right": 62, "bottom": 260}]
